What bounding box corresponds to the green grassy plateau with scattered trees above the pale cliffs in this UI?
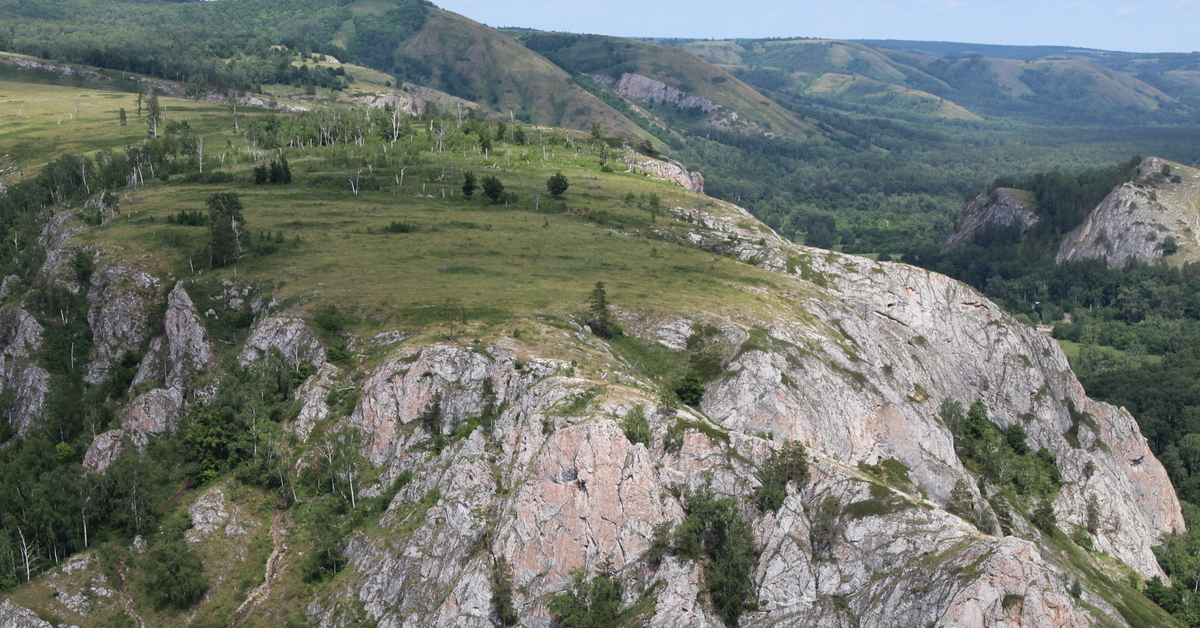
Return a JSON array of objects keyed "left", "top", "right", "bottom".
[{"left": 0, "top": 71, "right": 796, "bottom": 341}]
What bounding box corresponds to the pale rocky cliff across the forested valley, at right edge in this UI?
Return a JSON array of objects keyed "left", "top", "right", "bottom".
[{"left": 1056, "top": 157, "right": 1200, "bottom": 268}]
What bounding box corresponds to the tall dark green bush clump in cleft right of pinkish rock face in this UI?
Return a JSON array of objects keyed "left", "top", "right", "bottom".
[{"left": 673, "top": 483, "right": 760, "bottom": 626}]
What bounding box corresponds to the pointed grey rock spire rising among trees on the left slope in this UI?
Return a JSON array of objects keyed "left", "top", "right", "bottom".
[{"left": 133, "top": 283, "right": 214, "bottom": 390}]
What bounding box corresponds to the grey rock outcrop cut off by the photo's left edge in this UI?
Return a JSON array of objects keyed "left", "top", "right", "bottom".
[{"left": 0, "top": 307, "right": 50, "bottom": 435}]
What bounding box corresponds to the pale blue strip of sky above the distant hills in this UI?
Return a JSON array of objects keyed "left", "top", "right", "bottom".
[{"left": 433, "top": 0, "right": 1200, "bottom": 53}]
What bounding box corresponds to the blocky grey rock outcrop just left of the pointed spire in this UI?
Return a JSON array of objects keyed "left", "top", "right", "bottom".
[{"left": 84, "top": 260, "right": 162, "bottom": 384}]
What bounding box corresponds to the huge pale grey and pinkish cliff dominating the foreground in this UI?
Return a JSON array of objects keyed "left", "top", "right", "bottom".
[{"left": 290, "top": 201, "right": 1183, "bottom": 627}]
